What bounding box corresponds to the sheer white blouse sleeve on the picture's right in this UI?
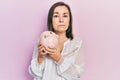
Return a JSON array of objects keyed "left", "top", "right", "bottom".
[{"left": 57, "top": 40, "right": 84, "bottom": 80}]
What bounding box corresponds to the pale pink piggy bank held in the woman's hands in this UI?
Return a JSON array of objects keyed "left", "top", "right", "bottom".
[{"left": 39, "top": 31, "right": 58, "bottom": 48}]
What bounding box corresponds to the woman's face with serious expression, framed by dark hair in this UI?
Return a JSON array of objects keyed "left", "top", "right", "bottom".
[{"left": 52, "top": 6, "right": 70, "bottom": 32}]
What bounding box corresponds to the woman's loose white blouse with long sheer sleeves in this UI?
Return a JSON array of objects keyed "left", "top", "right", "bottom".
[{"left": 29, "top": 38, "right": 84, "bottom": 80}]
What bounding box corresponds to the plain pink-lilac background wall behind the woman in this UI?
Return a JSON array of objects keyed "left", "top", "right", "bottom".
[{"left": 0, "top": 0, "right": 120, "bottom": 80}]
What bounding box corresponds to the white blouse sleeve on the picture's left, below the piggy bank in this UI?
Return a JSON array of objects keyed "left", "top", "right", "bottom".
[{"left": 29, "top": 42, "right": 45, "bottom": 78}]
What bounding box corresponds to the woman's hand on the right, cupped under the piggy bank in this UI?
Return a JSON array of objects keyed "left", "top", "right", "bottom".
[{"left": 46, "top": 47, "right": 62, "bottom": 62}]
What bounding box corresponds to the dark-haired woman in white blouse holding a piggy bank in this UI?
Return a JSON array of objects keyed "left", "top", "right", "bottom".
[{"left": 29, "top": 2, "right": 84, "bottom": 80}]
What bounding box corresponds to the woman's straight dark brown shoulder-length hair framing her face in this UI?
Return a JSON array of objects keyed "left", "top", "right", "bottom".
[{"left": 47, "top": 2, "right": 73, "bottom": 40}]
